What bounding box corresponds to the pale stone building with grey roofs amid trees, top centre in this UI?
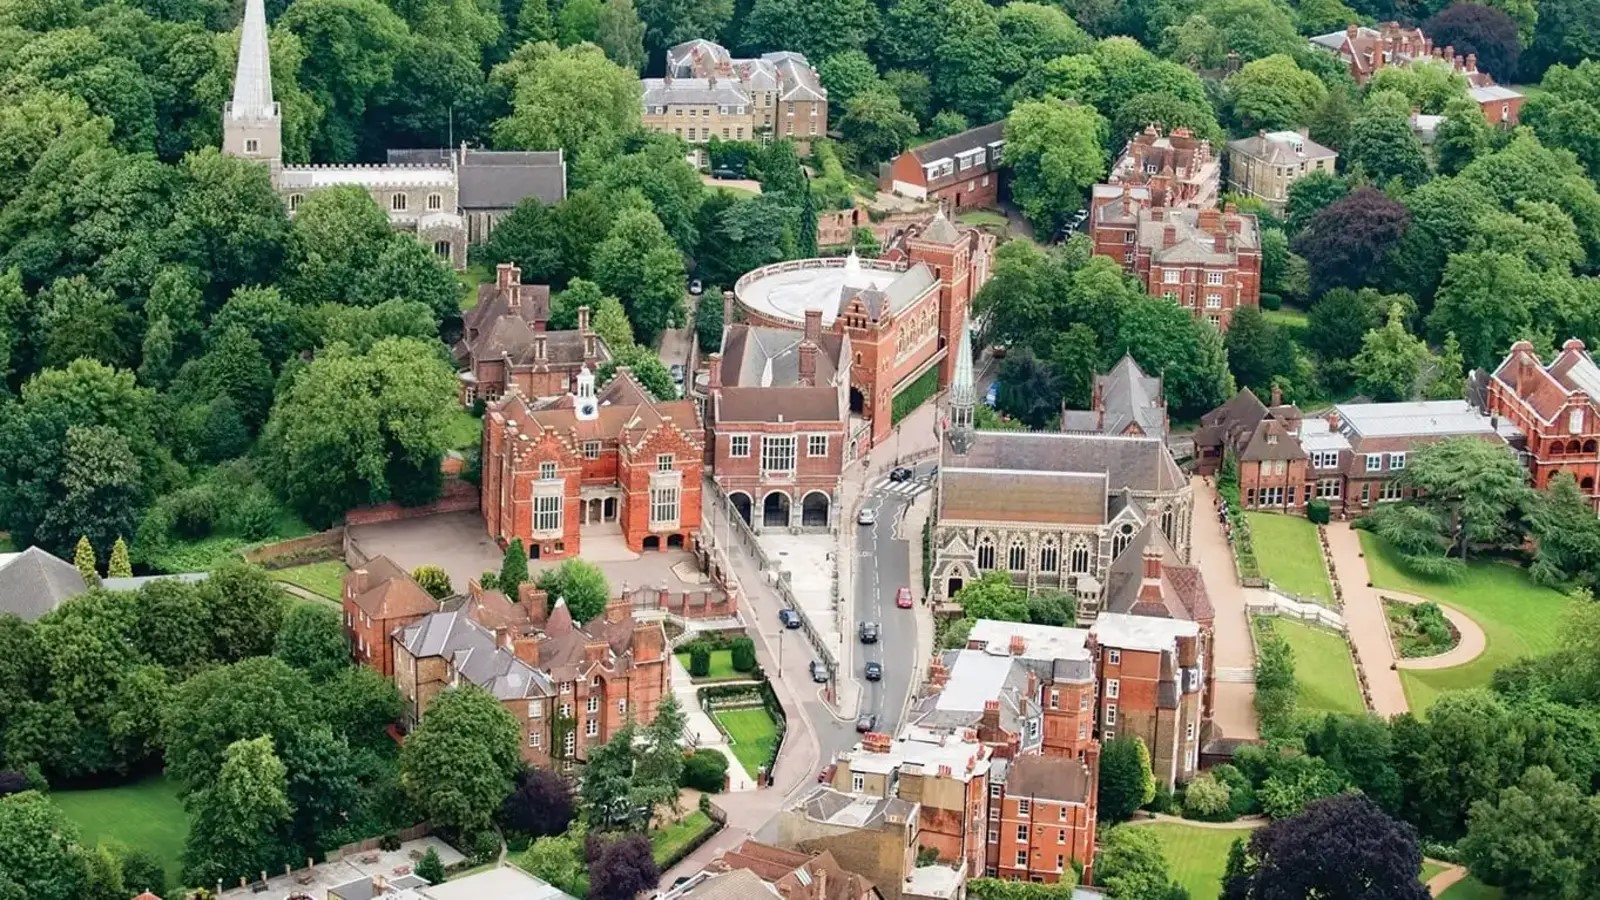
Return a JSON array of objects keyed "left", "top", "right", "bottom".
[{"left": 640, "top": 40, "right": 827, "bottom": 154}]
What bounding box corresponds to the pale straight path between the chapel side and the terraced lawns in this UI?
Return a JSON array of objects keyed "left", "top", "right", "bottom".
[{"left": 1190, "top": 476, "right": 1261, "bottom": 738}]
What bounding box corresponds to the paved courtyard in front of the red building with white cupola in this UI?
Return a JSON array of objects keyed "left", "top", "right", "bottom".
[{"left": 350, "top": 512, "right": 699, "bottom": 593}]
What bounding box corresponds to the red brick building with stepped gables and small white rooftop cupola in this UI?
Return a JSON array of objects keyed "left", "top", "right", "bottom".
[{"left": 480, "top": 367, "right": 706, "bottom": 559}]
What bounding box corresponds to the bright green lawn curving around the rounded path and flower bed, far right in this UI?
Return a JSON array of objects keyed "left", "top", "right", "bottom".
[{"left": 1358, "top": 532, "right": 1571, "bottom": 714}]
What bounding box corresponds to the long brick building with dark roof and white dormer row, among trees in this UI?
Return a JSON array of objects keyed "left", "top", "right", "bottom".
[{"left": 878, "top": 122, "right": 1005, "bottom": 210}]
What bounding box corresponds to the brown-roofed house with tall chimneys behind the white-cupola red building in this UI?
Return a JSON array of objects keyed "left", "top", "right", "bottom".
[{"left": 453, "top": 263, "right": 611, "bottom": 398}]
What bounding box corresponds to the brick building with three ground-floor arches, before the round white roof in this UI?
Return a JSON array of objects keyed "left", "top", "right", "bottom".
[{"left": 706, "top": 309, "right": 853, "bottom": 530}]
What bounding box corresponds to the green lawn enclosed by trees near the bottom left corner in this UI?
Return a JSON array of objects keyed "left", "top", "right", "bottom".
[{"left": 50, "top": 775, "right": 189, "bottom": 890}]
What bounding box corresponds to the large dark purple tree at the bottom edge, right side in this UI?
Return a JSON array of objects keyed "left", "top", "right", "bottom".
[{"left": 1222, "top": 794, "right": 1429, "bottom": 900}]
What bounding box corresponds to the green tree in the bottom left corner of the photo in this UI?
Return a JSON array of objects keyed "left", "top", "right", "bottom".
[{"left": 0, "top": 791, "right": 88, "bottom": 900}]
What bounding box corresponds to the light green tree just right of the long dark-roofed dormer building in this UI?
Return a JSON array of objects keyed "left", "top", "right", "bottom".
[{"left": 1005, "top": 99, "right": 1107, "bottom": 234}]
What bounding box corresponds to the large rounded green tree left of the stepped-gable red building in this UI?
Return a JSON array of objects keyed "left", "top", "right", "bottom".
[{"left": 264, "top": 338, "right": 456, "bottom": 524}]
